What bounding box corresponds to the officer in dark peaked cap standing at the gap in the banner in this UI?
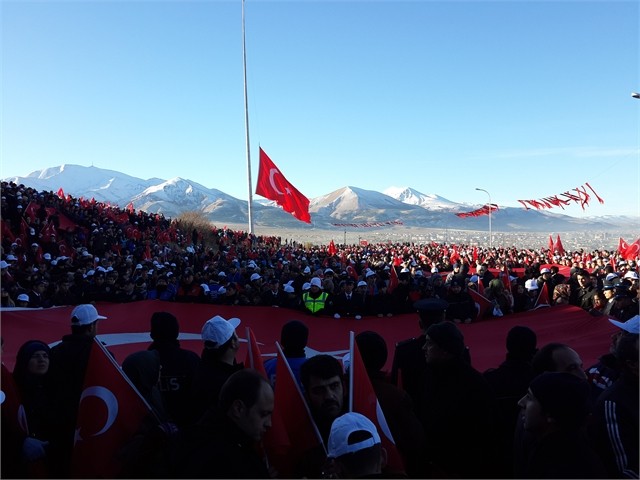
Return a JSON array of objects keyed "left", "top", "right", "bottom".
[{"left": 391, "top": 298, "right": 449, "bottom": 405}]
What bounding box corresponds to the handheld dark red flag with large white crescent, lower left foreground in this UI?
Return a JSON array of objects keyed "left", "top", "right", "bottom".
[{"left": 71, "top": 339, "right": 153, "bottom": 478}]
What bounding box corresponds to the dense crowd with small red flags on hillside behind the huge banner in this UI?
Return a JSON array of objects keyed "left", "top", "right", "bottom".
[{"left": 0, "top": 182, "right": 638, "bottom": 321}]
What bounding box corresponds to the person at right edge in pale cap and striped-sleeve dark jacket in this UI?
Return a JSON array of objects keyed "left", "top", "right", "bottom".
[{"left": 590, "top": 315, "right": 640, "bottom": 478}]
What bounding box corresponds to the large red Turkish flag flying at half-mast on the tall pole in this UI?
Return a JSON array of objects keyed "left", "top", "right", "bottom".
[{"left": 256, "top": 148, "right": 311, "bottom": 223}]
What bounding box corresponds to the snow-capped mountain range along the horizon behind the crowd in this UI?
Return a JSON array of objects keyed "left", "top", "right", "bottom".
[{"left": 4, "top": 165, "right": 638, "bottom": 232}]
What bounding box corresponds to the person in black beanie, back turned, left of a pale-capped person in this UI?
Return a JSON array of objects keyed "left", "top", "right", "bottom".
[{"left": 148, "top": 312, "right": 200, "bottom": 427}]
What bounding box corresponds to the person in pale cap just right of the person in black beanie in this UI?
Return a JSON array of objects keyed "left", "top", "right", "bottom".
[{"left": 194, "top": 315, "right": 244, "bottom": 418}]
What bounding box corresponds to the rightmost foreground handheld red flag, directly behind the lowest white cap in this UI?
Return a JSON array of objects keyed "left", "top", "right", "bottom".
[{"left": 349, "top": 332, "right": 406, "bottom": 474}]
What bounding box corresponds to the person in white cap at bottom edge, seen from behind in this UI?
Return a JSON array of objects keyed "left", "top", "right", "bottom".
[{"left": 325, "top": 412, "right": 387, "bottom": 478}]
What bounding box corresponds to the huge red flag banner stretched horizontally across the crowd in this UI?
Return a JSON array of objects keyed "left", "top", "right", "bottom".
[{"left": 1, "top": 300, "right": 616, "bottom": 376}]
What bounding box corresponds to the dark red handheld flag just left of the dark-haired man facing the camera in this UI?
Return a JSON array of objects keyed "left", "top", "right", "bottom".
[{"left": 264, "top": 342, "right": 326, "bottom": 478}]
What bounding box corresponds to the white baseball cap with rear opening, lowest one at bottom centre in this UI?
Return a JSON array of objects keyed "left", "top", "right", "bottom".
[{"left": 327, "top": 412, "right": 381, "bottom": 458}]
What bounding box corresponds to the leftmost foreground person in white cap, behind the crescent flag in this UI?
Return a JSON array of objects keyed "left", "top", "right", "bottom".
[{"left": 49, "top": 304, "right": 107, "bottom": 478}]
